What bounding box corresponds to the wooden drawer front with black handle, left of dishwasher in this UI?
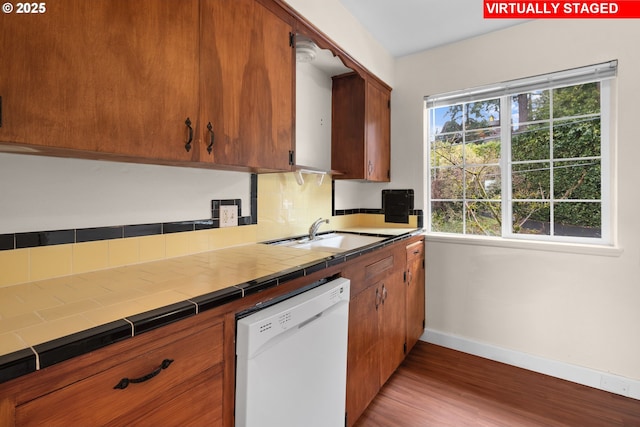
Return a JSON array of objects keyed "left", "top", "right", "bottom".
[{"left": 16, "top": 323, "right": 223, "bottom": 426}]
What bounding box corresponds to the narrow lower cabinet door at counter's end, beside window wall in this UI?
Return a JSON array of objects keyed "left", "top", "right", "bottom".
[{"left": 406, "top": 240, "right": 425, "bottom": 352}]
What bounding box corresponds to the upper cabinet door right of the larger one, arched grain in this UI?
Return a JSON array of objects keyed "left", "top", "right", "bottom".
[{"left": 200, "top": 0, "right": 295, "bottom": 170}]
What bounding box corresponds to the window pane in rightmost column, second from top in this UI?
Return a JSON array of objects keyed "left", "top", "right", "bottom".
[{"left": 553, "top": 116, "right": 600, "bottom": 159}]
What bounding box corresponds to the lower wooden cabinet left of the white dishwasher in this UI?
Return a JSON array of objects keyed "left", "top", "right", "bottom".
[{"left": 0, "top": 314, "right": 230, "bottom": 427}]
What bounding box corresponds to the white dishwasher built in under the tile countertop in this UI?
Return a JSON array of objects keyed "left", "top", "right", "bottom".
[{"left": 235, "top": 278, "right": 350, "bottom": 427}]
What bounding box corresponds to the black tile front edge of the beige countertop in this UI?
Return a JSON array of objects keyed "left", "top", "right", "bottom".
[{"left": 0, "top": 228, "right": 422, "bottom": 384}]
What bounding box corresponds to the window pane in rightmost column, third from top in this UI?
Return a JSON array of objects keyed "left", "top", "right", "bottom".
[{"left": 553, "top": 160, "right": 601, "bottom": 200}]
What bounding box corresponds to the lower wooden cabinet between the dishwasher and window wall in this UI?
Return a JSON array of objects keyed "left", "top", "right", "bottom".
[{"left": 343, "top": 238, "right": 425, "bottom": 426}]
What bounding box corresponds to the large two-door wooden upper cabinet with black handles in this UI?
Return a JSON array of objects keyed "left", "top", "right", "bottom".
[{"left": 0, "top": 0, "right": 295, "bottom": 170}]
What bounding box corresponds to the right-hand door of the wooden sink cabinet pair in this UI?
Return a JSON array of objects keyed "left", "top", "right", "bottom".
[{"left": 380, "top": 274, "right": 406, "bottom": 385}]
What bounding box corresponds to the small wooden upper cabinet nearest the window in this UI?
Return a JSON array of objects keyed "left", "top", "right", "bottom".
[{"left": 331, "top": 73, "right": 391, "bottom": 182}]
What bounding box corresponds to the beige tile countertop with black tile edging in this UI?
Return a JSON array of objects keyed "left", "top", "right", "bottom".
[{"left": 0, "top": 227, "right": 421, "bottom": 383}]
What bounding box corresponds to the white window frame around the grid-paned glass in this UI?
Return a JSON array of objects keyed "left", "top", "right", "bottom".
[{"left": 424, "top": 60, "right": 617, "bottom": 250}]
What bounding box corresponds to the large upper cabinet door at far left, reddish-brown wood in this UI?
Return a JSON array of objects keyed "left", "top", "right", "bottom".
[{"left": 0, "top": 0, "right": 198, "bottom": 160}]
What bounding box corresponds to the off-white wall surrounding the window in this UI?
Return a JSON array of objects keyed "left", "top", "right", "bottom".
[{"left": 392, "top": 20, "right": 640, "bottom": 382}]
